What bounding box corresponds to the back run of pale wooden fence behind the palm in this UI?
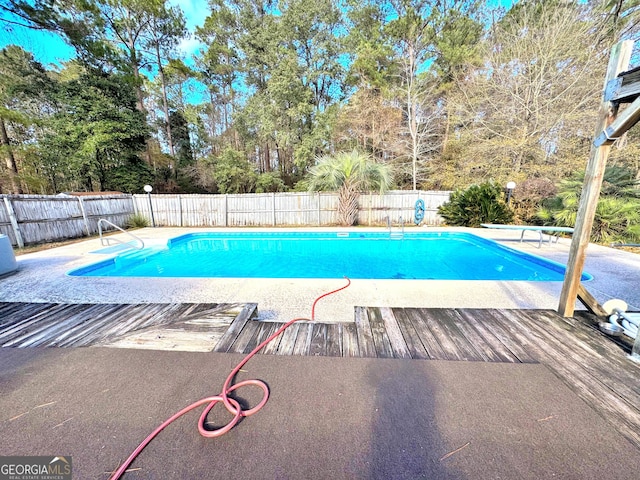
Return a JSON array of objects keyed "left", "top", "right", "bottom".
[{"left": 133, "top": 190, "right": 450, "bottom": 227}]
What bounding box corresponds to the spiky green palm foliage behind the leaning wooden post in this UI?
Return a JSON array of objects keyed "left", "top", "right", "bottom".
[{"left": 538, "top": 166, "right": 640, "bottom": 243}]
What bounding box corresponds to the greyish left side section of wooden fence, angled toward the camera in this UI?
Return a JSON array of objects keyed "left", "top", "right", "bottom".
[{"left": 0, "top": 195, "right": 134, "bottom": 248}]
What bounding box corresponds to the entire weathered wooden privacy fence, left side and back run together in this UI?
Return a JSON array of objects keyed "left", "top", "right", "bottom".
[{"left": 0, "top": 190, "right": 450, "bottom": 248}]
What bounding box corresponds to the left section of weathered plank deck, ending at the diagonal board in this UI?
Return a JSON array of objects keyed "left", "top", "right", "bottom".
[{"left": 0, "top": 303, "right": 257, "bottom": 352}]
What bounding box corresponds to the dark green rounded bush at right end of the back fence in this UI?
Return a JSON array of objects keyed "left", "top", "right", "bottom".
[{"left": 438, "top": 182, "right": 513, "bottom": 227}]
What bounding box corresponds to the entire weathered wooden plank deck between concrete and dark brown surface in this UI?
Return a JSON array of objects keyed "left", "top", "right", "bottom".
[{"left": 0, "top": 303, "right": 640, "bottom": 448}]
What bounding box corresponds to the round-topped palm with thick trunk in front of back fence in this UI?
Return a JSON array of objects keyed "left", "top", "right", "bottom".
[{"left": 306, "top": 150, "right": 391, "bottom": 227}]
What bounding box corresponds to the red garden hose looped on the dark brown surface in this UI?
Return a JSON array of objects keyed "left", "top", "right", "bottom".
[{"left": 109, "top": 277, "right": 351, "bottom": 480}]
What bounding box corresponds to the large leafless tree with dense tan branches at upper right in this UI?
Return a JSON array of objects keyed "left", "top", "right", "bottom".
[{"left": 451, "top": 2, "right": 606, "bottom": 187}]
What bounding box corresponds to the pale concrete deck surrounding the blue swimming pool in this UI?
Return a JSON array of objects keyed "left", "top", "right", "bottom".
[{"left": 0, "top": 228, "right": 640, "bottom": 322}]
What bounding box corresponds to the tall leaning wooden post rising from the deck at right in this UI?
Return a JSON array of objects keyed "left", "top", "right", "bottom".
[{"left": 558, "top": 40, "right": 640, "bottom": 317}]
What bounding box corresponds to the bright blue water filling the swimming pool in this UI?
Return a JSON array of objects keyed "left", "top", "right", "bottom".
[{"left": 69, "top": 232, "right": 591, "bottom": 281}]
